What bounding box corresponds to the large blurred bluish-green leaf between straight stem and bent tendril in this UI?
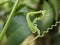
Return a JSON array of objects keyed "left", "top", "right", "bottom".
[{"left": 6, "top": 15, "right": 31, "bottom": 45}]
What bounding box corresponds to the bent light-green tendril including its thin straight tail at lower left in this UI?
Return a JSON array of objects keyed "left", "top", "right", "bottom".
[{"left": 26, "top": 10, "right": 46, "bottom": 44}]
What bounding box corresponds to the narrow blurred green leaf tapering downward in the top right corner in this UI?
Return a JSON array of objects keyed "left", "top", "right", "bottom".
[{"left": 49, "top": 0, "right": 60, "bottom": 21}]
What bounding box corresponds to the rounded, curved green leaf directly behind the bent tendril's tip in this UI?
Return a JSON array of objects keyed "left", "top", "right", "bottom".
[{"left": 37, "top": 1, "right": 55, "bottom": 34}]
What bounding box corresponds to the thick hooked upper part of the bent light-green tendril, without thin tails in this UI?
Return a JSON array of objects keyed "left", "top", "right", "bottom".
[{"left": 26, "top": 10, "right": 45, "bottom": 33}]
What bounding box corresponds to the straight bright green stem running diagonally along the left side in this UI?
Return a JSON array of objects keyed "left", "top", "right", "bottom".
[{"left": 0, "top": 0, "right": 19, "bottom": 41}]
